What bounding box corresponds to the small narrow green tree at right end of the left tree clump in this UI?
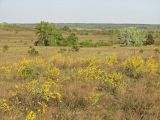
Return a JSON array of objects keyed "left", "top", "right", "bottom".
[{"left": 67, "top": 33, "right": 79, "bottom": 51}]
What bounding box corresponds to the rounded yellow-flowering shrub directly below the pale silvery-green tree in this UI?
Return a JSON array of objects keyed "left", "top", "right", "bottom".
[{"left": 123, "top": 56, "right": 146, "bottom": 78}]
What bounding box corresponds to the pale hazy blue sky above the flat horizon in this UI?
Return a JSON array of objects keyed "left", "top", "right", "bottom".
[{"left": 0, "top": 0, "right": 160, "bottom": 24}]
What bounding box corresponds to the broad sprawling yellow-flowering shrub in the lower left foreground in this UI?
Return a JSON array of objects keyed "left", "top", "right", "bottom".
[{"left": 10, "top": 80, "right": 61, "bottom": 111}]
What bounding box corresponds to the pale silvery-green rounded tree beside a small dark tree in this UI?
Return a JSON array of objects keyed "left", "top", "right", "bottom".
[{"left": 120, "top": 27, "right": 144, "bottom": 46}]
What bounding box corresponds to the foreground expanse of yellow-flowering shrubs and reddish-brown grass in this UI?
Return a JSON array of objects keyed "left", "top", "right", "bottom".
[{"left": 0, "top": 54, "right": 160, "bottom": 120}]
